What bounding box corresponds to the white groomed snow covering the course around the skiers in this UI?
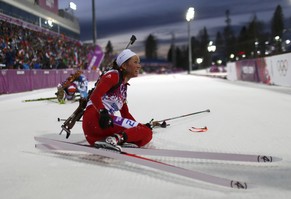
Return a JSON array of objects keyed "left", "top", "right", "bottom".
[{"left": 0, "top": 74, "right": 291, "bottom": 199}]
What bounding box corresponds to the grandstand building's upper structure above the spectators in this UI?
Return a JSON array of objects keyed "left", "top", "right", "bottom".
[{"left": 0, "top": 0, "right": 80, "bottom": 40}]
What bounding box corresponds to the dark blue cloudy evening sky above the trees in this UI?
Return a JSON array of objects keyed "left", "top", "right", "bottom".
[{"left": 59, "top": 0, "right": 291, "bottom": 54}]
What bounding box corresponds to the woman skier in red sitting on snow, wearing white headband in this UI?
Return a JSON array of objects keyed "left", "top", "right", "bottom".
[{"left": 83, "top": 49, "right": 152, "bottom": 151}]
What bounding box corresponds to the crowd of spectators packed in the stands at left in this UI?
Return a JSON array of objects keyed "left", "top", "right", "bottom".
[{"left": 0, "top": 20, "right": 93, "bottom": 69}]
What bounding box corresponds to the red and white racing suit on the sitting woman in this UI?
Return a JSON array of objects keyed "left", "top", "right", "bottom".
[{"left": 83, "top": 70, "right": 152, "bottom": 146}]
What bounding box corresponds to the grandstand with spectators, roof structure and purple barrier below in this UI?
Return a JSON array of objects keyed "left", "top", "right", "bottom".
[{"left": 0, "top": 0, "right": 99, "bottom": 94}]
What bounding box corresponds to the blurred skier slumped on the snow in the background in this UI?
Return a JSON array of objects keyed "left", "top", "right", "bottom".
[{"left": 56, "top": 70, "right": 88, "bottom": 103}]
